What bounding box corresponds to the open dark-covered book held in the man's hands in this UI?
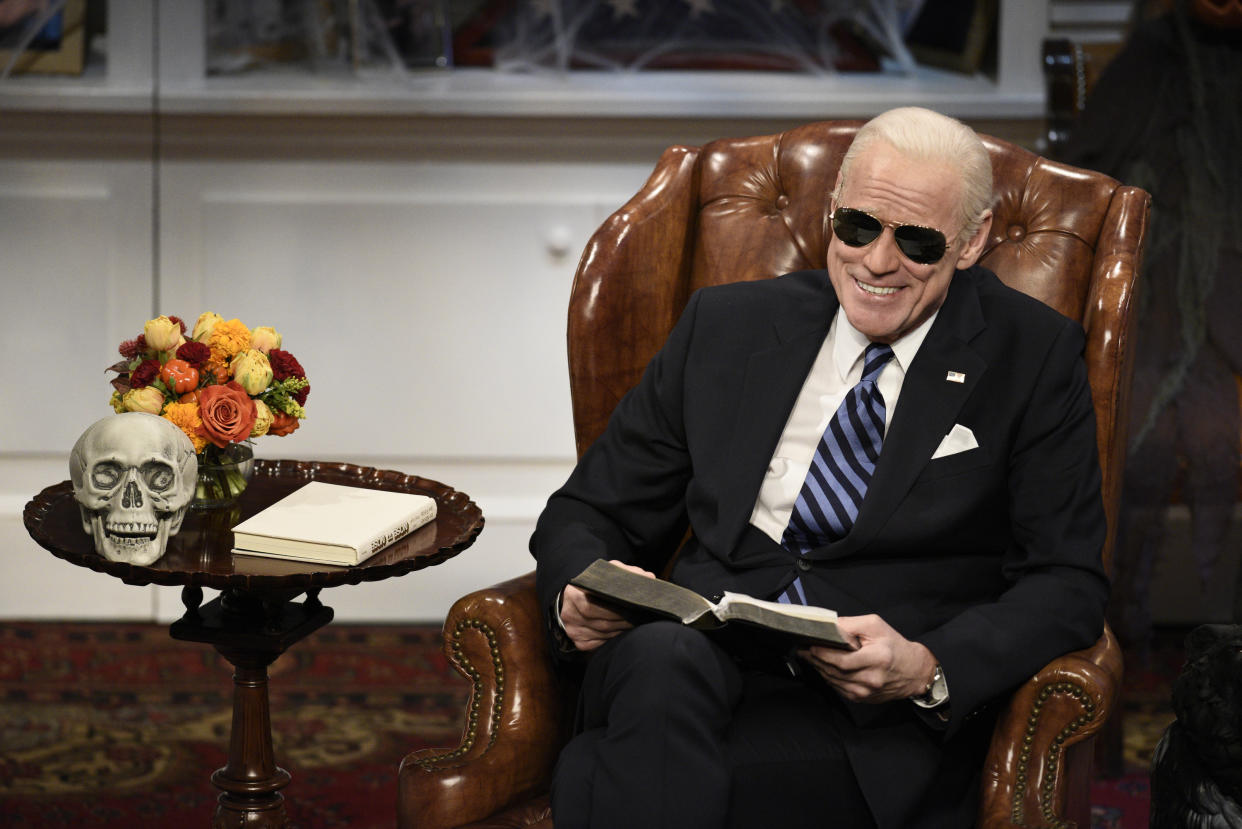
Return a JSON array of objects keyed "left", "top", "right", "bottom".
[{"left": 569, "top": 558, "right": 856, "bottom": 650}]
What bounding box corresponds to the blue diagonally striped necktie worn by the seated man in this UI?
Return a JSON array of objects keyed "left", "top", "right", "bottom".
[{"left": 780, "top": 343, "right": 893, "bottom": 604}]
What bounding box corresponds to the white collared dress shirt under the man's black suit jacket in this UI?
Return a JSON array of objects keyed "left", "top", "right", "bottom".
[{"left": 750, "top": 307, "right": 936, "bottom": 543}]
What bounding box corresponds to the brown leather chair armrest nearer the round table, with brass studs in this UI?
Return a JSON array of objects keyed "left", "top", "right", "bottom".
[{"left": 397, "top": 573, "right": 566, "bottom": 829}]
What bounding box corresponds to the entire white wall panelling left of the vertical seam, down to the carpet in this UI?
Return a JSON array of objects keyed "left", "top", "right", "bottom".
[{"left": 0, "top": 157, "right": 154, "bottom": 618}]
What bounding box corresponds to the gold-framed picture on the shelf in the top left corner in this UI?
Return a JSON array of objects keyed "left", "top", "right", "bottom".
[{"left": 0, "top": 0, "right": 86, "bottom": 77}]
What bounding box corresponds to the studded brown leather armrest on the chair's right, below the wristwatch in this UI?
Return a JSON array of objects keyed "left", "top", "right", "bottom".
[{"left": 979, "top": 626, "right": 1122, "bottom": 829}]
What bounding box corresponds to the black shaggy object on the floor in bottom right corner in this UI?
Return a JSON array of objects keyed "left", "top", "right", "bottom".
[{"left": 1151, "top": 625, "right": 1242, "bottom": 829}]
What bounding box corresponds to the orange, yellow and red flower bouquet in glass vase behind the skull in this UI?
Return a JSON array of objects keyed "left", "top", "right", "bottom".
[{"left": 108, "top": 311, "right": 311, "bottom": 507}]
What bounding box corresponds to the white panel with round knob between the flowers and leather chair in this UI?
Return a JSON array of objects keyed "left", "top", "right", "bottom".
[{"left": 160, "top": 162, "right": 645, "bottom": 459}]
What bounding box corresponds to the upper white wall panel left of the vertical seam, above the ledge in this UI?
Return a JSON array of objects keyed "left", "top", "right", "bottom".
[{"left": 0, "top": 160, "right": 152, "bottom": 454}]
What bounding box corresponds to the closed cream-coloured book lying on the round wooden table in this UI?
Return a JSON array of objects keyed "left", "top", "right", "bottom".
[{"left": 232, "top": 481, "right": 436, "bottom": 566}]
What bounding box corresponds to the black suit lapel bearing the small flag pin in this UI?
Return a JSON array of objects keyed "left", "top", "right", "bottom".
[{"left": 816, "top": 273, "right": 987, "bottom": 558}]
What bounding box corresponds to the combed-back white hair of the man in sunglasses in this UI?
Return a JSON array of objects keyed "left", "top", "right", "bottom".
[{"left": 832, "top": 107, "right": 994, "bottom": 240}]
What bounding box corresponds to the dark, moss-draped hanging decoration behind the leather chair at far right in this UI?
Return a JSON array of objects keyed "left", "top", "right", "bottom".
[{"left": 1062, "top": 0, "right": 1242, "bottom": 644}]
